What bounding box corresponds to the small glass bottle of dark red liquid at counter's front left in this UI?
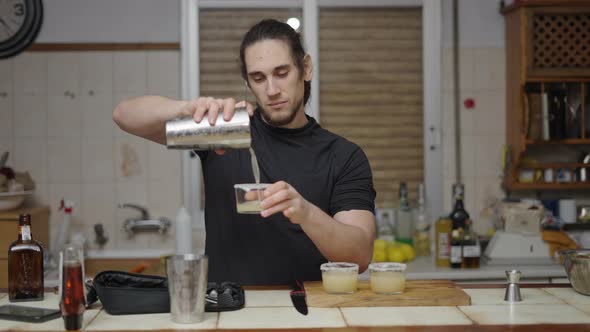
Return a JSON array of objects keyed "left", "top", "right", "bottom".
[{"left": 59, "top": 246, "right": 86, "bottom": 331}]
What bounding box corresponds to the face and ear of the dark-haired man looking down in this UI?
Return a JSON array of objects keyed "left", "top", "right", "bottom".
[{"left": 244, "top": 39, "right": 311, "bottom": 128}]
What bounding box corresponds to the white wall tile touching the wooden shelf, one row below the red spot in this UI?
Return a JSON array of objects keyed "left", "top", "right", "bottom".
[{"left": 471, "top": 135, "right": 505, "bottom": 178}]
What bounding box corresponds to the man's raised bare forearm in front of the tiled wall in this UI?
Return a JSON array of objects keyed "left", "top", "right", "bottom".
[{"left": 113, "top": 96, "right": 186, "bottom": 144}]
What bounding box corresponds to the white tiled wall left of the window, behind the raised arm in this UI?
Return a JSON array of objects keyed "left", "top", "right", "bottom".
[{"left": 0, "top": 51, "right": 181, "bottom": 249}]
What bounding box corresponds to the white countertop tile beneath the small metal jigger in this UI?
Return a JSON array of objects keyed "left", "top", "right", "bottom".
[{"left": 463, "top": 288, "right": 564, "bottom": 305}]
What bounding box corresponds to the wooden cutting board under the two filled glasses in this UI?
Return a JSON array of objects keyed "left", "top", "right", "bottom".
[{"left": 305, "top": 280, "right": 471, "bottom": 308}]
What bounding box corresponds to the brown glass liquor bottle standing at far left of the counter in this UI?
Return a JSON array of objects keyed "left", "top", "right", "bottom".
[{"left": 8, "top": 214, "right": 43, "bottom": 302}]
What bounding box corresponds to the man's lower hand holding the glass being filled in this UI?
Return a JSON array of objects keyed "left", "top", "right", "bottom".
[{"left": 260, "top": 181, "right": 313, "bottom": 224}]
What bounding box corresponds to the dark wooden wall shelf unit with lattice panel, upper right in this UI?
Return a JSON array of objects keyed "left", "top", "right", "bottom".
[{"left": 502, "top": 0, "right": 590, "bottom": 191}]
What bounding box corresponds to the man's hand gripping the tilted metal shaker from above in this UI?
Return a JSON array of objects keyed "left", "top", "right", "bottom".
[{"left": 181, "top": 97, "right": 254, "bottom": 126}]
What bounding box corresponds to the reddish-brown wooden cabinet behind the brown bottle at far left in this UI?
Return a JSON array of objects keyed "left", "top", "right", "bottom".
[{"left": 0, "top": 206, "right": 50, "bottom": 288}]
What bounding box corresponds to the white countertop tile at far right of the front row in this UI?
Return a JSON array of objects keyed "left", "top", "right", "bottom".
[{"left": 459, "top": 303, "right": 590, "bottom": 325}]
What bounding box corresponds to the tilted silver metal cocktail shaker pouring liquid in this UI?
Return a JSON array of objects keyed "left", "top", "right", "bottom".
[{"left": 166, "top": 108, "right": 251, "bottom": 150}]
